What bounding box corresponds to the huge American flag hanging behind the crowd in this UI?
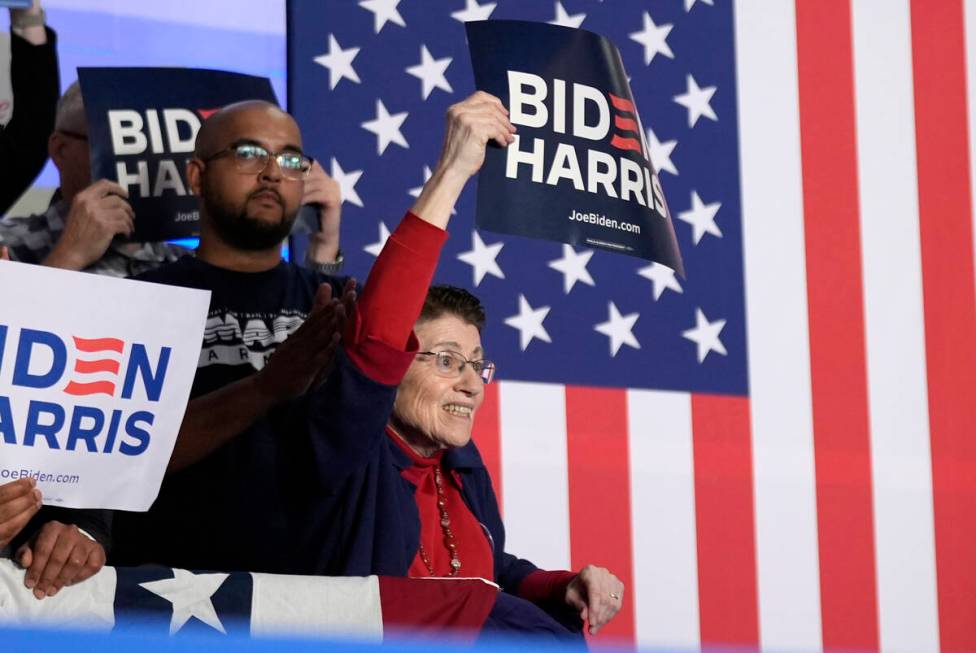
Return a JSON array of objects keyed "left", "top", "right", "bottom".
[{"left": 288, "top": 0, "right": 976, "bottom": 651}]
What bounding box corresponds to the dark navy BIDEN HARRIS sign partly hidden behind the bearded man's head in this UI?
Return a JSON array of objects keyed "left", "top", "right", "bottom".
[{"left": 78, "top": 68, "right": 277, "bottom": 242}]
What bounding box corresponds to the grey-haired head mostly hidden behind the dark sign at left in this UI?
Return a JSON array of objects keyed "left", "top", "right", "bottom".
[{"left": 47, "top": 82, "right": 91, "bottom": 203}]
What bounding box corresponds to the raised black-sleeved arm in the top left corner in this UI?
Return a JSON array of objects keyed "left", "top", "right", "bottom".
[{"left": 0, "top": 0, "right": 61, "bottom": 215}]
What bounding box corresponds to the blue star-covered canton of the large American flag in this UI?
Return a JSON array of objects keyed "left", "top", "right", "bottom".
[{"left": 289, "top": 0, "right": 748, "bottom": 394}]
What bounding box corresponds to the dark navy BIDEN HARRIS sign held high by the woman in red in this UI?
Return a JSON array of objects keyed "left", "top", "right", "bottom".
[{"left": 465, "top": 20, "right": 684, "bottom": 275}]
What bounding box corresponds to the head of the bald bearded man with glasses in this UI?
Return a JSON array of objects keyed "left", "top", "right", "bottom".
[{"left": 187, "top": 100, "right": 312, "bottom": 255}]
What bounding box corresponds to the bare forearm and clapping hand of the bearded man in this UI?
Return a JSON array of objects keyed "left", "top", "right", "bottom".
[{"left": 167, "top": 279, "right": 356, "bottom": 472}]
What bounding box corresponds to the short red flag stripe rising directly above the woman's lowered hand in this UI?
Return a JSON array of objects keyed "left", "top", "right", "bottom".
[{"left": 566, "top": 387, "right": 635, "bottom": 643}]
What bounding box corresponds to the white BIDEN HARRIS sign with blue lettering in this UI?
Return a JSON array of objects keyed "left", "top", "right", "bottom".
[{"left": 0, "top": 261, "right": 210, "bottom": 511}]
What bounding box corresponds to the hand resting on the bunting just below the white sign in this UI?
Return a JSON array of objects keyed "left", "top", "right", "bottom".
[{"left": 16, "top": 521, "right": 105, "bottom": 599}]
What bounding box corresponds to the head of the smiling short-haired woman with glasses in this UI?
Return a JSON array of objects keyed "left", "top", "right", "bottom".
[{"left": 392, "top": 286, "right": 495, "bottom": 455}]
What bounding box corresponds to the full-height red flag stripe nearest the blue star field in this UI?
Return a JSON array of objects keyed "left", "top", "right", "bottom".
[{"left": 796, "top": 0, "right": 878, "bottom": 650}]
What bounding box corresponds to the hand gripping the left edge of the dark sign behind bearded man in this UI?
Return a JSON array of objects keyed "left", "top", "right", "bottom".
[{"left": 44, "top": 179, "right": 135, "bottom": 270}]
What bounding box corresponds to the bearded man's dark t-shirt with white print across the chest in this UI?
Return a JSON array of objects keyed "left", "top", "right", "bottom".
[{"left": 111, "top": 256, "right": 343, "bottom": 572}]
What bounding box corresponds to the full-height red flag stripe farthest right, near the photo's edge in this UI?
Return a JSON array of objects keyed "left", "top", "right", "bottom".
[{"left": 911, "top": 0, "right": 976, "bottom": 651}]
